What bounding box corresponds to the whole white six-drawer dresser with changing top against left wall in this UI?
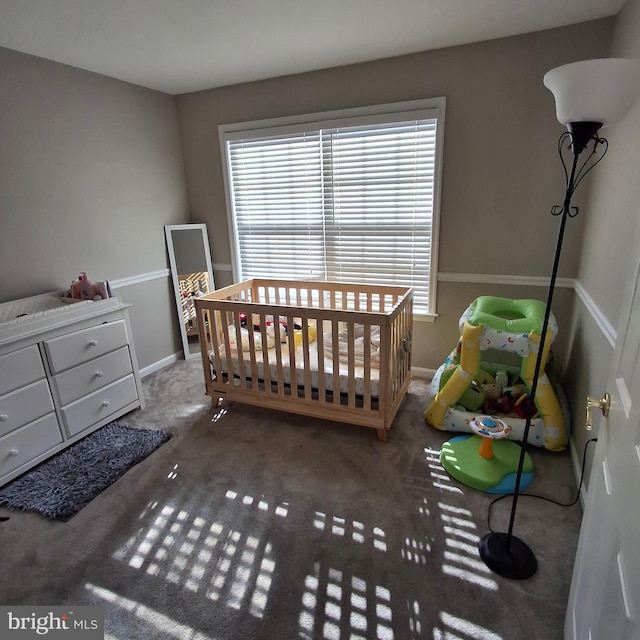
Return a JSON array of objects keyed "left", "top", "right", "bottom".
[{"left": 0, "top": 292, "right": 144, "bottom": 485}]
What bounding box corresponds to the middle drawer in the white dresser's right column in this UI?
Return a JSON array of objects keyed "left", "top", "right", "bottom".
[{"left": 53, "top": 347, "right": 133, "bottom": 405}]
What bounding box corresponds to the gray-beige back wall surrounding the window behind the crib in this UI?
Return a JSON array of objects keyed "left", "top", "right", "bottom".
[{"left": 177, "top": 20, "right": 612, "bottom": 369}]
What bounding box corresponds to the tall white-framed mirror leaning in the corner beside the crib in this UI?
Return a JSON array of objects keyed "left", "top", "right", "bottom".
[{"left": 164, "top": 224, "right": 215, "bottom": 358}]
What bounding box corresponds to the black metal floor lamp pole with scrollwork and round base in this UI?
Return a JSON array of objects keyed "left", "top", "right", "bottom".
[{"left": 478, "top": 122, "right": 608, "bottom": 580}]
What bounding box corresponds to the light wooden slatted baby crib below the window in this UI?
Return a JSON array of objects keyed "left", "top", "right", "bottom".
[{"left": 195, "top": 279, "right": 413, "bottom": 442}]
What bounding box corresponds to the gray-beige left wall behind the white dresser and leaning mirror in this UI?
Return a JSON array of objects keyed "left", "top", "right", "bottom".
[{"left": 0, "top": 48, "right": 188, "bottom": 367}]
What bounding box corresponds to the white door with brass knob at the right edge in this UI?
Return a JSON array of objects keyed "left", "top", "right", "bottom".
[{"left": 565, "top": 258, "right": 640, "bottom": 640}]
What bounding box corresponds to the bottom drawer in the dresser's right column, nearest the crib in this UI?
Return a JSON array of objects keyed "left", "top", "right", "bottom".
[{"left": 62, "top": 375, "right": 138, "bottom": 437}]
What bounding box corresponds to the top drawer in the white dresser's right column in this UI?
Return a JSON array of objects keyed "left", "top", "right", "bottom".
[{"left": 44, "top": 320, "right": 128, "bottom": 373}]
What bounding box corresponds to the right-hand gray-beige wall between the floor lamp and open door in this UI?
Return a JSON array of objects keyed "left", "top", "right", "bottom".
[{"left": 565, "top": 0, "right": 640, "bottom": 484}]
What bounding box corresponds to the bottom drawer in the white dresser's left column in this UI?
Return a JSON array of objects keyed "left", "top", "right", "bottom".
[{"left": 0, "top": 413, "right": 62, "bottom": 476}]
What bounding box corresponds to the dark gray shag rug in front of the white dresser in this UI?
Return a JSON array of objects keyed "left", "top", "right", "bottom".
[{"left": 0, "top": 422, "right": 171, "bottom": 520}]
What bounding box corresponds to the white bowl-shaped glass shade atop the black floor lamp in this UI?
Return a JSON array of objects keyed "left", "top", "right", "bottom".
[{"left": 543, "top": 58, "right": 640, "bottom": 127}]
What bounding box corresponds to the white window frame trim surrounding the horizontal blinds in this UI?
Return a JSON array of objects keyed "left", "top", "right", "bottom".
[{"left": 218, "top": 97, "right": 446, "bottom": 319}]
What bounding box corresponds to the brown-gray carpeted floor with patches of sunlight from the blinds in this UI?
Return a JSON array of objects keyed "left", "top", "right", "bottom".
[{"left": 0, "top": 359, "right": 581, "bottom": 640}]
